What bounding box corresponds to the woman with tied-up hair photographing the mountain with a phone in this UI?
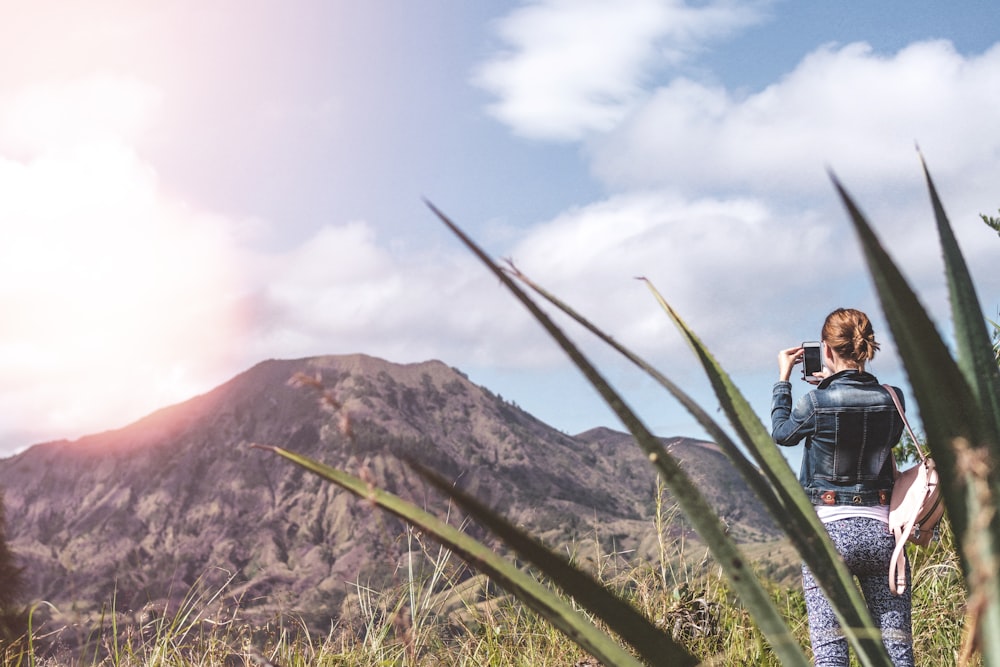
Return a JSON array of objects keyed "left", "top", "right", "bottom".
[{"left": 771, "top": 308, "right": 913, "bottom": 667}]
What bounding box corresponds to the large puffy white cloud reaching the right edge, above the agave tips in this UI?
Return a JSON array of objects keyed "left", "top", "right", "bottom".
[{"left": 594, "top": 41, "right": 1000, "bottom": 195}]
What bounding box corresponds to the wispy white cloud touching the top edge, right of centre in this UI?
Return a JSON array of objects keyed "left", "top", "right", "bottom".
[{"left": 475, "top": 0, "right": 756, "bottom": 140}]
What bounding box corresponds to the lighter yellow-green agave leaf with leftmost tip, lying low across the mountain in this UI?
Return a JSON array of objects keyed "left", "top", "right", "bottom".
[{"left": 256, "top": 445, "right": 642, "bottom": 667}]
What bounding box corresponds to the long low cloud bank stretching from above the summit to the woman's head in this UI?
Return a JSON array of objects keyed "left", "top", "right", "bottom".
[{"left": 247, "top": 175, "right": 996, "bottom": 404}]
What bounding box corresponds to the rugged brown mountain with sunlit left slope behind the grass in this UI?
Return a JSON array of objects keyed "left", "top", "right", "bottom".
[{"left": 0, "top": 355, "right": 776, "bottom": 629}]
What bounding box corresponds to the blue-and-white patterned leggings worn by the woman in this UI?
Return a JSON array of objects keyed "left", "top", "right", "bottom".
[{"left": 802, "top": 517, "right": 913, "bottom": 667}]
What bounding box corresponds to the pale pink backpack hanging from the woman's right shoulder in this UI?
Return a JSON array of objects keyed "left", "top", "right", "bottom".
[{"left": 883, "top": 385, "right": 944, "bottom": 595}]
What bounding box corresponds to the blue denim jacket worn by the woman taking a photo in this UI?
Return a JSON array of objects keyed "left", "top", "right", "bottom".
[{"left": 771, "top": 370, "right": 903, "bottom": 505}]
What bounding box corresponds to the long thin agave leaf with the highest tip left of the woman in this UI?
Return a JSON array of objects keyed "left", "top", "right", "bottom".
[{"left": 427, "top": 202, "right": 808, "bottom": 666}]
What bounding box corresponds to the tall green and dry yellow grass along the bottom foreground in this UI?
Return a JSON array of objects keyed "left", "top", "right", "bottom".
[{"left": 0, "top": 510, "right": 980, "bottom": 667}]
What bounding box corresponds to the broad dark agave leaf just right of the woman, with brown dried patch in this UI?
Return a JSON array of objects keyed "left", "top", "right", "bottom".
[{"left": 833, "top": 172, "right": 1000, "bottom": 665}]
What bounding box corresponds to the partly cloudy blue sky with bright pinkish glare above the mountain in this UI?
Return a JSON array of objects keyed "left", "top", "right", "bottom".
[{"left": 0, "top": 0, "right": 1000, "bottom": 456}]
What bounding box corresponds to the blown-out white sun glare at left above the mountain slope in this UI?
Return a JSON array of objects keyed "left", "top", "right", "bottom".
[{"left": 0, "top": 81, "right": 244, "bottom": 444}]
